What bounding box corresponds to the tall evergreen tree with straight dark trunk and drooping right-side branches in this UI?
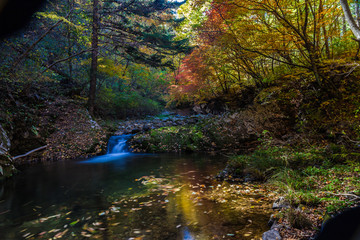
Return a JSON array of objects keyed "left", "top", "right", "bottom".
[{"left": 88, "top": 0, "right": 189, "bottom": 114}]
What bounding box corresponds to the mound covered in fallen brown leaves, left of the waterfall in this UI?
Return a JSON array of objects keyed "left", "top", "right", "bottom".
[{"left": 39, "top": 99, "right": 106, "bottom": 161}]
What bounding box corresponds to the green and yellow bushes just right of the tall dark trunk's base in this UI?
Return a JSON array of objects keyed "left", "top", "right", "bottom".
[{"left": 95, "top": 59, "right": 169, "bottom": 118}]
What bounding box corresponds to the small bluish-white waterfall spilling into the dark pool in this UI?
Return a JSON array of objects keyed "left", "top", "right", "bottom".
[{"left": 81, "top": 134, "right": 133, "bottom": 163}]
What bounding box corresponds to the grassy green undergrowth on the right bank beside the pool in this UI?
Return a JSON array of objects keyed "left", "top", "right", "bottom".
[{"left": 228, "top": 134, "right": 360, "bottom": 212}]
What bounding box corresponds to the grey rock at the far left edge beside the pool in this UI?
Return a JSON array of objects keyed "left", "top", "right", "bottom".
[{"left": 0, "top": 125, "right": 16, "bottom": 178}]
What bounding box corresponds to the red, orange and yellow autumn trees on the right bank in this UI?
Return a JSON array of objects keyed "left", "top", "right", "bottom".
[{"left": 171, "top": 0, "right": 357, "bottom": 104}]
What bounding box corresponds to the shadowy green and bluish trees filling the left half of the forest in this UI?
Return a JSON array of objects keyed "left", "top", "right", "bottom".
[{"left": 0, "top": 0, "right": 190, "bottom": 117}]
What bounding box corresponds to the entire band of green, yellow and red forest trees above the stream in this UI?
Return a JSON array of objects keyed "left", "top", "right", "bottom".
[{"left": 0, "top": 0, "right": 360, "bottom": 118}]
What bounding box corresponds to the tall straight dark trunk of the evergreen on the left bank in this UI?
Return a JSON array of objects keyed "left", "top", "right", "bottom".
[{"left": 88, "top": 0, "right": 100, "bottom": 115}]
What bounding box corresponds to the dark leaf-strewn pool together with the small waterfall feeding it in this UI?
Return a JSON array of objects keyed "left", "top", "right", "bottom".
[{"left": 0, "top": 135, "right": 270, "bottom": 240}]
